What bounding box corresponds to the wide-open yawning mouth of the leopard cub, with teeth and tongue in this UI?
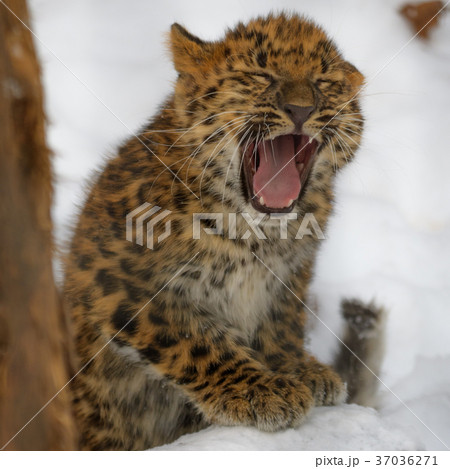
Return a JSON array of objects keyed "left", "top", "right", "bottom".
[{"left": 243, "top": 134, "right": 319, "bottom": 213}]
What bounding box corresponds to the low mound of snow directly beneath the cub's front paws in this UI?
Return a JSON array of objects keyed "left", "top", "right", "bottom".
[{"left": 156, "top": 404, "right": 417, "bottom": 451}]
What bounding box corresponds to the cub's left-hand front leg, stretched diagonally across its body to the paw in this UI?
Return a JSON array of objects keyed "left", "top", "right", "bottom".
[{"left": 107, "top": 292, "right": 314, "bottom": 431}]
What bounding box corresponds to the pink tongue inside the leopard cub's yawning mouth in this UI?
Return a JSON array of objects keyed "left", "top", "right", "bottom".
[{"left": 253, "top": 135, "right": 301, "bottom": 208}]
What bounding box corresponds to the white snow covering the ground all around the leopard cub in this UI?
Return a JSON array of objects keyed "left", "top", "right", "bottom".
[{"left": 30, "top": 0, "right": 450, "bottom": 450}]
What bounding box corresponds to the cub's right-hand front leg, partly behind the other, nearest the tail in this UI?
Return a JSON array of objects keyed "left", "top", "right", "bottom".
[{"left": 252, "top": 280, "right": 347, "bottom": 405}]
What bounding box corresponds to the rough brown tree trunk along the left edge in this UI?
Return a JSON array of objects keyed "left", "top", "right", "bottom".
[{"left": 0, "top": 0, "right": 77, "bottom": 450}]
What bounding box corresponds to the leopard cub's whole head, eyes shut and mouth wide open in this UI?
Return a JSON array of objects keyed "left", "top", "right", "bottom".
[{"left": 170, "top": 14, "right": 363, "bottom": 213}]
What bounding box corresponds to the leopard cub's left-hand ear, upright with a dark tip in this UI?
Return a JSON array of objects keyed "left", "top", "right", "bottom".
[{"left": 169, "top": 23, "right": 214, "bottom": 75}]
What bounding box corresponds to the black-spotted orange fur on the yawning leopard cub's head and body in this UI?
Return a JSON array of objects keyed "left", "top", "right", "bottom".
[{"left": 65, "top": 14, "right": 363, "bottom": 449}]
